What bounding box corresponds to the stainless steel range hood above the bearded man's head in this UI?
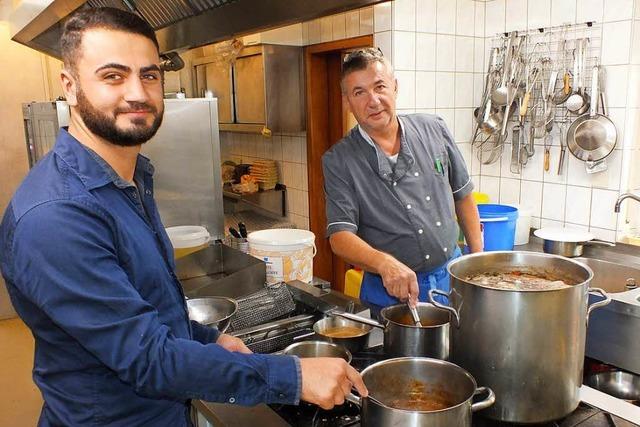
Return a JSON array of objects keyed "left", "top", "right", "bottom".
[{"left": 13, "top": 0, "right": 382, "bottom": 58}]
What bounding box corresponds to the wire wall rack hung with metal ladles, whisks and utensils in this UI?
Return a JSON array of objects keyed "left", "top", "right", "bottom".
[{"left": 472, "top": 22, "right": 602, "bottom": 167}]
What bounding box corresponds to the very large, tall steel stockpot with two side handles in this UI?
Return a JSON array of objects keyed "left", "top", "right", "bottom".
[{"left": 429, "top": 252, "right": 611, "bottom": 424}]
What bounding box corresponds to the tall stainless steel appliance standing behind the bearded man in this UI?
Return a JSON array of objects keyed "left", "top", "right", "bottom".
[{"left": 23, "top": 98, "right": 224, "bottom": 239}]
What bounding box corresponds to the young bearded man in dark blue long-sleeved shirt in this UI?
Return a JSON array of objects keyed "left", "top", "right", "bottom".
[{"left": 0, "top": 8, "right": 366, "bottom": 426}]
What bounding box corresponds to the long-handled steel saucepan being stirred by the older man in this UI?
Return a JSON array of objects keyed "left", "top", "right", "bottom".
[{"left": 336, "top": 302, "right": 449, "bottom": 360}]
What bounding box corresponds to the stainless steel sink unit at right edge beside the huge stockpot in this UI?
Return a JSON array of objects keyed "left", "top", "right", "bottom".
[{"left": 574, "top": 258, "right": 640, "bottom": 374}]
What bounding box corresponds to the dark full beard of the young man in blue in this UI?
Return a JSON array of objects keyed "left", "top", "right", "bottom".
[{"left": 76, "top": 88, "right": 164, "bottom": 147}]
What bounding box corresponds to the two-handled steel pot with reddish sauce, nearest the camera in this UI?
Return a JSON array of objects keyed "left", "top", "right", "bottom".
[{"left": 348, "top": 357, "right": 495, "bottom": 427}]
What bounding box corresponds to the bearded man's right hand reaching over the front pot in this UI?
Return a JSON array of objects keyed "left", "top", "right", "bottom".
[{"left": 300, "top": 357, "right": 368, "bottom": 409}]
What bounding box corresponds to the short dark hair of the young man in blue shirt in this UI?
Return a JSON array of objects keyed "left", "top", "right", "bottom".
[{"left": 60, "top": 6, "right": 160, "bottom": 72}]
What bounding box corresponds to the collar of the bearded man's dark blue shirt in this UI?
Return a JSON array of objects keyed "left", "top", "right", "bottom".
[{"left": 53, "top": 127, "right": 154, "bottom": 190}]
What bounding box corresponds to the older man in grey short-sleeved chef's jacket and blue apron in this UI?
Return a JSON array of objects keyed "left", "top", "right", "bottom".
[{"left": 322, "top": 48, "right": 482, "bottom": 306}]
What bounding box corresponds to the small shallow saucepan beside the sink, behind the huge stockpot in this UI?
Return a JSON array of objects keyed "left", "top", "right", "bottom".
[{"left": 533, "top": 227, "right": 615, "bottom": 258}]
